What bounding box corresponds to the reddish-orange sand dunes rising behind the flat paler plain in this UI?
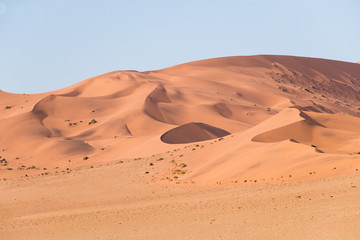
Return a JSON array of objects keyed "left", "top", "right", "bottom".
[{"left": 0, "top": 56, "right": 360, "bottom": 183}]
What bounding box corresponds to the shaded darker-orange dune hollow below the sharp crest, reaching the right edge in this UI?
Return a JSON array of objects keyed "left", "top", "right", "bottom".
[{"left": 251, "top": 112, "right": 360, "bottom": 154}]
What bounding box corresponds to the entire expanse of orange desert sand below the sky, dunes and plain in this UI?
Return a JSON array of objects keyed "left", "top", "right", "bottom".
[{"left": 0, "top": 55, "right": 360, "bottom": 240}]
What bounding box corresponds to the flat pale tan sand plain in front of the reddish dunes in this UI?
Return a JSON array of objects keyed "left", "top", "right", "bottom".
[{"left": 0, "top": 161, "right": 360, "bottom": 240}]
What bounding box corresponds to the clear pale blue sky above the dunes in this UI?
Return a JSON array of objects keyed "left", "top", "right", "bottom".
[{"left": 0, "top": 0, "right": 360, "bottom": 93}]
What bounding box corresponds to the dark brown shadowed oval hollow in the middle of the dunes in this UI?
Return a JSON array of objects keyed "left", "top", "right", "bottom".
[{"left": 160, "top": 122, "right": 231, "bottom": 144}]
